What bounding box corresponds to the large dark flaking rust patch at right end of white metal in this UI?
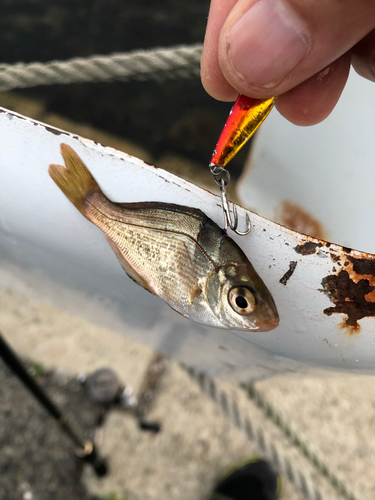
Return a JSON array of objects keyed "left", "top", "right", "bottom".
[{"left": 322, "top": 251, "right": 375, "bottom": 334}]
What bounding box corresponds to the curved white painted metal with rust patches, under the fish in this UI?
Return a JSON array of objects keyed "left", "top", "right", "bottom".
[{"left": 0, "top": 106, "right": 375, "bottom": 379}]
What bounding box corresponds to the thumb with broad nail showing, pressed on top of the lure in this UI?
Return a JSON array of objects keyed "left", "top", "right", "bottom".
[{"left": 219, "top": 0, "right": 375, "bottom": 98}]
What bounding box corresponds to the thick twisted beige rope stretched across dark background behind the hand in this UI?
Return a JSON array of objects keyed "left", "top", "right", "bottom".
[{"left": 0, "top": 44, "right": 202, "bottom": 91}]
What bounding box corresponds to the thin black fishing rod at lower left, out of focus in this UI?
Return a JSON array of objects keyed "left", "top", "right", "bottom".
[{"left": 0, "top": 333, "right": 108, "bottom": 477}]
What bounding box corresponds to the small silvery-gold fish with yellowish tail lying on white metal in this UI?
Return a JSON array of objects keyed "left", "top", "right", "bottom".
[{"left": 49, "top": 143, "right": 279, "bottom": 332}]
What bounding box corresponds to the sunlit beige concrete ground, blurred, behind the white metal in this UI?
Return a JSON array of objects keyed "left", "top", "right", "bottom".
[{"left": 0, "top": 94, "right": 375, "bottom": 500}]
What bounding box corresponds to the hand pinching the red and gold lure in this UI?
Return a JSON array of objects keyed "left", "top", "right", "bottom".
[{"left": 201, "top": 0, "right": 375, "bottom": 125}]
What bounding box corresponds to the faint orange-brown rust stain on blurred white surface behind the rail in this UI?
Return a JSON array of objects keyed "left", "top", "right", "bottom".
[{"left": 278, "top": 200, "right": 325, "bottom": 239}]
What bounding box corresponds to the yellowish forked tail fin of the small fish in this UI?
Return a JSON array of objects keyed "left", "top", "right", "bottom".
[{"left": 48, "top": 144, "right": 101, "bottom": 217}]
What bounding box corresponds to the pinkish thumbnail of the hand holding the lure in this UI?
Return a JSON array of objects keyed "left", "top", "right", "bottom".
[{"left": 227, "top": 0, "right": 309, "bottom": 88}]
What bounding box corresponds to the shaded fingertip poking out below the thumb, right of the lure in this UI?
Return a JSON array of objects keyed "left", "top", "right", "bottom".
[{"left": 276, "top": 52, "right": 351, "bottom": 126}]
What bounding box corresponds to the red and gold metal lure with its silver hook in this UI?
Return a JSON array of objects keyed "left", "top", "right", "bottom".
[{"left": 209, "top": 94, "right": 277, "bottom": 236}]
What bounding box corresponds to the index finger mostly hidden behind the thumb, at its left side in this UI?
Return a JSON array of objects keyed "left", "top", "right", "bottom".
[{"left": 201, "top": 0, "right": 238, "bottom": 101}]
